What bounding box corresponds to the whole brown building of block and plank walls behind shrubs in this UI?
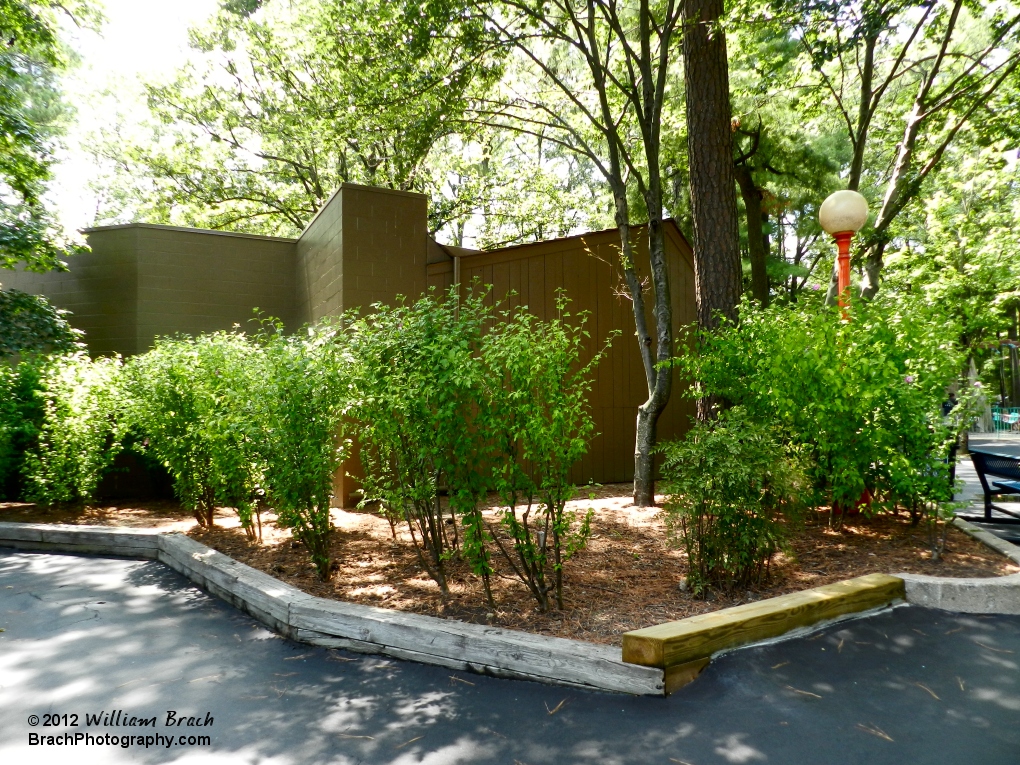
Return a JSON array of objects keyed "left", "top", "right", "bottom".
[{"left": 0, "top": 184, "right": 696, "bottom": 504}]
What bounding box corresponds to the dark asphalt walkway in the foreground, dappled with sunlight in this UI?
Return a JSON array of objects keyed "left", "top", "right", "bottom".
[{"left": 0, "top": 551, "right": 1020, "bottom": 765}]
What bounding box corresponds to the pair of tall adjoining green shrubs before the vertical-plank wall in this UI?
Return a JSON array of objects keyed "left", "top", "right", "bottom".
[{"left": 355, "top": 290, "right": 601, "bottom": 610}]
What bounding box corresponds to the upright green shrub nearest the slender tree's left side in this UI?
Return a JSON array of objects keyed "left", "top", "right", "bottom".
[{"left": 482, "top": 295, "right": 612, "bottom": 611}]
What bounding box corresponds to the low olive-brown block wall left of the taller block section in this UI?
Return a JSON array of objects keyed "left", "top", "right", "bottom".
[{"left": 0, "top": 223, "right": 296, "bottom": 356}]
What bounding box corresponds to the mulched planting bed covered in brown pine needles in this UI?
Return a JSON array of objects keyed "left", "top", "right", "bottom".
[{"left": 0, "top": 485, "right": 1020, "bottom": 645}]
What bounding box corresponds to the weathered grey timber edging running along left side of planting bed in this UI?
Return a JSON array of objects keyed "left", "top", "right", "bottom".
[{"left": 0, "top": 523, "right": 665, "bottom": 696}]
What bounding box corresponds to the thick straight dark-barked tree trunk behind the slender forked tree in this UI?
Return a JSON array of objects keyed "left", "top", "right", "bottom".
[{"left": 683, "top": 0, "right": 741, "bottom": 419}]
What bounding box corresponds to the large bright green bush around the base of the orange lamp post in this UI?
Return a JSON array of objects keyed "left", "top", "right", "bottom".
[{"left": 678, "top": 295, "right": 963, "bottom": 522}]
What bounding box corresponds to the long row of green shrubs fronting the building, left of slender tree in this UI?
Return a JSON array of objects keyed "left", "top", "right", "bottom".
[{"left": 0, "top": 290, "right": 602, "bottom": 599}]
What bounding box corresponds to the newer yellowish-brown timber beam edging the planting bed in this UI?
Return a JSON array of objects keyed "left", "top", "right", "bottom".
[{"left": 623, "top": 574, "right": 906, "bottom": 694}]
